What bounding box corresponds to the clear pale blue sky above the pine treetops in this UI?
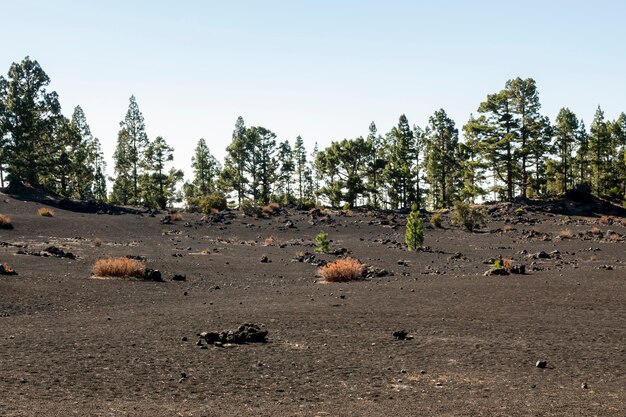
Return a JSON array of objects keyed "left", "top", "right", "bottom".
[{"left": 0, "top": 0, "right": 626, "bottom": 177}]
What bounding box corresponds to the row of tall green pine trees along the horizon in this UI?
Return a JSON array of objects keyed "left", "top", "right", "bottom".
[{"left": 0, "top": 57, "right": 626, "bottom": 209}]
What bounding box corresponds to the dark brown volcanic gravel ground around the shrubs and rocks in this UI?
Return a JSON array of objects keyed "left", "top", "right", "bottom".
[{"left": 0, "top": 196, "right": 626, "bottom": 417}]
